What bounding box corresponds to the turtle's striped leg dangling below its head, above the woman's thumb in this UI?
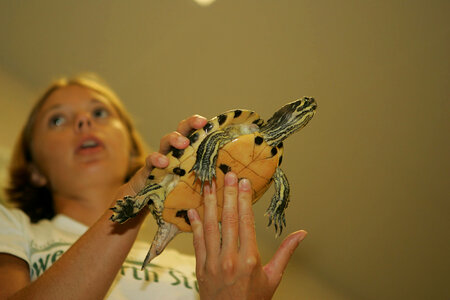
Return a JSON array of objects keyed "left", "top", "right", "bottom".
[{"left": 265, "top": 168, "right": 290, "bottom": 237}]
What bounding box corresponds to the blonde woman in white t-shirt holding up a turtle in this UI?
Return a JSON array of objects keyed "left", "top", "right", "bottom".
[{"left": 0, "top": 76, "right": 306, "bottom": 299}]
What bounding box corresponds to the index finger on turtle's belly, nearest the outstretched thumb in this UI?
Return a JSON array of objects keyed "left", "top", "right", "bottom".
[{"left": 238, "top": 178, "right": 258, "bottom": 253}]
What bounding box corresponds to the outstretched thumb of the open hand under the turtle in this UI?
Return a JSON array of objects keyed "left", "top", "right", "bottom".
[{"left": 264, "top": 230, "right": 307, "bottom": 287}]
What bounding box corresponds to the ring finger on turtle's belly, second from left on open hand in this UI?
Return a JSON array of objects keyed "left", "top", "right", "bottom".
[{"left": 203, "top": 182, "right": 220, "bottom": 264}]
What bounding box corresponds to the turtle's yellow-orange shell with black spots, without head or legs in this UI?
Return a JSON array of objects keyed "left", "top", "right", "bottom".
[{"left": 149, "top": 110, "right": 283, "bottom": 232}]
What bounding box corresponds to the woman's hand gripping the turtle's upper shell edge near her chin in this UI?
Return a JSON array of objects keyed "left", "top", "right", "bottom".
[{"left": 116, "top": 115, "right": 208, "bottom": 199}]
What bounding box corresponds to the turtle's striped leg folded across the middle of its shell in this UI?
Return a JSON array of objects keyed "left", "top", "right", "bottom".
[{"left": 191, "top": 130, "right": 231, "bottom": 193}]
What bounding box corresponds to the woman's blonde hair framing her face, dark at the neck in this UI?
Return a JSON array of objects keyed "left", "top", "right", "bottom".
[{"left": 5, "top": 73, "right": 146, "bottom": 222}]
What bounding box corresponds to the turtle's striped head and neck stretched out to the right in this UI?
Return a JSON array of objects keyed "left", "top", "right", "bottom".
[{"left": 261, "top": 97, "right": 317, "bottom": 146}]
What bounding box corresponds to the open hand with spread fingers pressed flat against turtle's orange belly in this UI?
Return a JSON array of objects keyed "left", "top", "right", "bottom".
[{"left": 188, "top": 172, "right": 306, "bottom": 300}]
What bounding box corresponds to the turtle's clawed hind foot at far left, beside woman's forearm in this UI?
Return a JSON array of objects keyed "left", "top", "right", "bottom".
[{"left": 110, "top": 183, "right": 161, "bottom": 223}]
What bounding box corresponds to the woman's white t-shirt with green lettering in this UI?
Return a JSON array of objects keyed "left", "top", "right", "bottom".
[{"left": 0, "top": 204, "right": 199, "bottom": 300}]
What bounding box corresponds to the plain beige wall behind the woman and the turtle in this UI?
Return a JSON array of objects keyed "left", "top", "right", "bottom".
[{"left": 0, "top": 0, "right": 450, "bottom": 299}]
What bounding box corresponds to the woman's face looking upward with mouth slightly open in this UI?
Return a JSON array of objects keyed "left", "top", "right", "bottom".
[{"left": 31, "top": 85, "right": 131, "bottom": 193}]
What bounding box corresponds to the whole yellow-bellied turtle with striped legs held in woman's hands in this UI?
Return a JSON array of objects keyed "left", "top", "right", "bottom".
[{"left": 110, "top": 97, "right": 317, "bottom": 268}]
